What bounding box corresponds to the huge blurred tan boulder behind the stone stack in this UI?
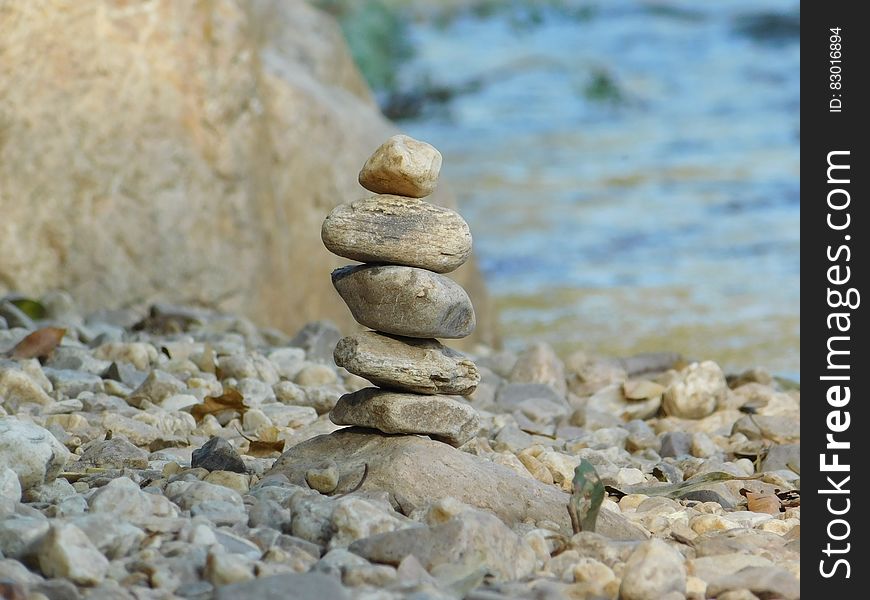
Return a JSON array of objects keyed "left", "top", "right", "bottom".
[{"left": 0, "top": 0, "right": 492, "bottom": 340}]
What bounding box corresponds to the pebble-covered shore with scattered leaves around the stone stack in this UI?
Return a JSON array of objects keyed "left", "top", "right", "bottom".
[{"left": 0, "top": 293, "right": 800, "bottom": 600}]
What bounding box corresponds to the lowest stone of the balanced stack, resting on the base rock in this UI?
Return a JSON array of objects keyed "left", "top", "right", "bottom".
[{"left": 329, "top": 388, "right": 480, "bottom": 446}]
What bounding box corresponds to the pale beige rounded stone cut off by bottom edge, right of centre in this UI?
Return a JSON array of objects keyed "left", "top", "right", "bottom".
[{"left": 620, "top": 540, "right": 686, "bottom": 600}]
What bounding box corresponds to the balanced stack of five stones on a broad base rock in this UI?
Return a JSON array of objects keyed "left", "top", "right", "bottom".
[{"left": 321, "top": 135, "right": 480, "bottom": 445}]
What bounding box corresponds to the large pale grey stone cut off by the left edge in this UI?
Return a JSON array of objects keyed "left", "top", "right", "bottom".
[{"left": 0, "top": 417, "right": 70, "bottom": 491}]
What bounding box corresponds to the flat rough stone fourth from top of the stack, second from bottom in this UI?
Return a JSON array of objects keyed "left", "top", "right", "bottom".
[{"left": 334, "top": 331, "right": 480, "bottom": 396}]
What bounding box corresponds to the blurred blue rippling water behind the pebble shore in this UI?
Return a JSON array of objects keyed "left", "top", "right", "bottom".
[{"left": 401, "top": 0, "right": 800, "bottom": 377}]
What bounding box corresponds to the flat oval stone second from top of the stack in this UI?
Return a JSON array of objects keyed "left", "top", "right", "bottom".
[{"left": 320, "top": 195, "right": 472, "bottom": 273}]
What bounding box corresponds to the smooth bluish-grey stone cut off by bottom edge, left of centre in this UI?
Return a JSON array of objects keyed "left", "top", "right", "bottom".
[{"left": 214, "top": 573, "right": 350, "bottom": 600}]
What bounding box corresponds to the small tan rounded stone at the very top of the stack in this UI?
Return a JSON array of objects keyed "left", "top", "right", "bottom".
[{"left": 359, "top": 135, "right": 441, "bottom": 198}]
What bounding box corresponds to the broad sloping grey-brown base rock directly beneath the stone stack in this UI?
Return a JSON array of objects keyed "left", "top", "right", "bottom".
[{"left": 266, "top": 427, "right": 571, "bottom": 533}]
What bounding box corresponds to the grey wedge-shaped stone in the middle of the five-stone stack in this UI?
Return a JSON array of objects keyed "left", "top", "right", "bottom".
[{"left": 332, "top": 265, "right": 475, "bottom": 338}]
